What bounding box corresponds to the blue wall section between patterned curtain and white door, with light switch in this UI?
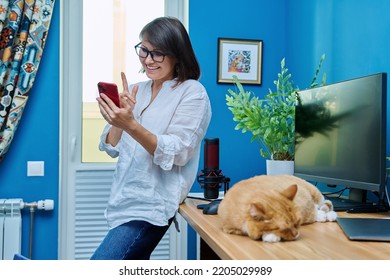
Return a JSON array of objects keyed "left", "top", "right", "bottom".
[{"left": 0, "top": 3, "right": 60, "bottom": 259}]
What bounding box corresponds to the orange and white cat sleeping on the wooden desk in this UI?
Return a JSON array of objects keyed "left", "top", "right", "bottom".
[{"left": 218, "top": 175, "right": 337, "bottom": 242}]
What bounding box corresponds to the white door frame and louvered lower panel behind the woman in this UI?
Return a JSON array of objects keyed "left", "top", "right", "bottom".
[{"left": 59, "top": 0, "right": 188, "bottom": 259}]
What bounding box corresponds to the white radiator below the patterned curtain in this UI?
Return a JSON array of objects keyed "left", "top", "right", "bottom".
[{"left": 0, "top": 199, "right": 23, "bottom": 260}]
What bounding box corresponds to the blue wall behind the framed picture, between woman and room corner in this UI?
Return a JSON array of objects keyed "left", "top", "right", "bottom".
[{"left": 189, "top": 0, "right": 287, "bottom": 191}]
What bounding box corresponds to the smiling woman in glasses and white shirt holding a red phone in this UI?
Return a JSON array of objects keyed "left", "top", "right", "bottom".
[{"left": 91, "top": 17, "right": 211, "bottom": 259}]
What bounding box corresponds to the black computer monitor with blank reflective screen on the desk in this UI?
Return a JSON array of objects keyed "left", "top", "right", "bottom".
[{"left": 294, "top": 73, "right": 387, "bottom": 210}]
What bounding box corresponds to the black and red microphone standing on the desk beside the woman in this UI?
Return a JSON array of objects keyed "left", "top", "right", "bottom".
[{"left": 197, "top": 138, "right": 230, "bottom": 199}]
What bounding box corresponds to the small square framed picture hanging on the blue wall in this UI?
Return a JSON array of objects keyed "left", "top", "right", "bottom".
[{"left": 217, "top": 38, "right": 263, "bottom": 85}]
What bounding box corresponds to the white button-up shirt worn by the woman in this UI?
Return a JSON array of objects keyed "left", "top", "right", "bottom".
[{"left": 99, "top": 80, "right": 211, "bottom": 228}]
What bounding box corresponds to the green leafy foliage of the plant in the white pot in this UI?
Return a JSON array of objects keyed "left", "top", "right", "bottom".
[{"left": 226, "top": 55, "right": 326, "bottom": 173}]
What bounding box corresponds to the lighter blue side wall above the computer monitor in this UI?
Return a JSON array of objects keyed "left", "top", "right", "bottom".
[{"left": 287, "top": 0, "right": 390, "bottom": 83}]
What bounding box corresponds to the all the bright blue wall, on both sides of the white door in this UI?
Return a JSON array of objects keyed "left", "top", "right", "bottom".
[{"left": 0, "top": 0, "right": 390, "bottom": 259}]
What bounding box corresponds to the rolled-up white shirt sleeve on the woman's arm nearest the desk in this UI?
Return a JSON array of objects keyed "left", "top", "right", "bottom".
[{"left": 153, "top": 81, "right": 211, "bottom": 170}]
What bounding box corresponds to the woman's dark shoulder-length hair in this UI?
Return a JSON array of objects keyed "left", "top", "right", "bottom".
[{"left": 140, "top": 17, "right": 200, "bottom": 83}]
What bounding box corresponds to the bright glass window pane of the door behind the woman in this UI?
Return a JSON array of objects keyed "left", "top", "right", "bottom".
[{"left": 81, "top": 0, "right": 165, "bottom": 163}]
